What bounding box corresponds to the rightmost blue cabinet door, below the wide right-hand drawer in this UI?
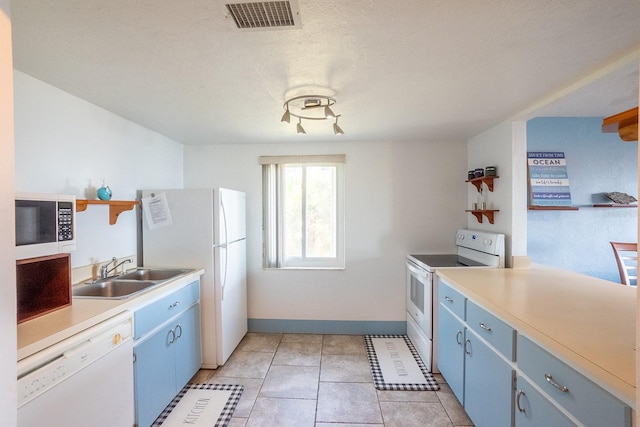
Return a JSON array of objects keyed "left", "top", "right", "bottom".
[{"left": 516, "top": 376, "right": 575, "bottom": 427}]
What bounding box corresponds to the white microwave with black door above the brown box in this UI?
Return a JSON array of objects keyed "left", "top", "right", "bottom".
[{"left": 15, "top": 193, "right": 76, "bottom": 260}]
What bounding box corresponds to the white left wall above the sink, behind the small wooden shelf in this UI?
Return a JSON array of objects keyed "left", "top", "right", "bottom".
[{"left": 14, "top": 70, "right": 183, "bottom": 267}]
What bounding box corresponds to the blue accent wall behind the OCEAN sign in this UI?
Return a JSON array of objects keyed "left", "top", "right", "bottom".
[{"left": 523, "top": 117, "right": 638, "bottom": 282}]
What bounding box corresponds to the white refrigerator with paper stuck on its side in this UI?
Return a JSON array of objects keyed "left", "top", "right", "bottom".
[{"left": 142, "top": 188, "right": 247, "bottom": 369}]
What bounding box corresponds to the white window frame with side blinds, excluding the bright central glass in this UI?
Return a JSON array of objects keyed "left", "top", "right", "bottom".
[{"left": 260, "top": 154, "right": 345, "bottom": 269}]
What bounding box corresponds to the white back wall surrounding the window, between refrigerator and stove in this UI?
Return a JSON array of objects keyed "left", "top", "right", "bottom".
[{"left": 184, "top": 140, "right": 467, "bottom": 321}]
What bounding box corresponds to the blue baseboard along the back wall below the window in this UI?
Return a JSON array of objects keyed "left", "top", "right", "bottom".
[{"left": 249, "top": 319, "right": 407, "bottom": 335}]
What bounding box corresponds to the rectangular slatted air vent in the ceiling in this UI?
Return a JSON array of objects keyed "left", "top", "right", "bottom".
[{"left": 225, "top": 1, "right": 299, "bottom": 29}]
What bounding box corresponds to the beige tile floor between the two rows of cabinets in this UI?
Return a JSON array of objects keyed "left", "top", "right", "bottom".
[{"left": 192, "top": 333, "right": 473, "bottom": 427}]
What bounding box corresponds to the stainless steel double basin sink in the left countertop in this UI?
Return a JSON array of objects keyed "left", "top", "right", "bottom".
[{"left": 72, "top": 268, "right": 191, "bottom": 299}]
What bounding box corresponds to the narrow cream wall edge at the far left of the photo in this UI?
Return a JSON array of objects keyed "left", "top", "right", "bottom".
[{"left": 0, "top": 0, "right": 17, "bottom": 426}]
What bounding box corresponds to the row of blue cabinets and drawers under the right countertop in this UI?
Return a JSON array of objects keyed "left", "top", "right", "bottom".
[{"left": 436, "top": 280, "right": 632, "bottom": 427}]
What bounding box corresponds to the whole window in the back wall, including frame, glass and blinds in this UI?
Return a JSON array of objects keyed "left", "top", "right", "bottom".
[{"left": 260, "top": 155, "right": 345, "bottom": 269}]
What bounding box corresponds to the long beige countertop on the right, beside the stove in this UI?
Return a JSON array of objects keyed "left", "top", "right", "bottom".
[{"left": 437, "top": 266, "right": 637, "bottom": 408}]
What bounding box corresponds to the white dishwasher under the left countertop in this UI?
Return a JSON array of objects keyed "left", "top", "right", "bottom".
[{"left": 18, "top": 312, "right": 134, "bottom": 427}]
